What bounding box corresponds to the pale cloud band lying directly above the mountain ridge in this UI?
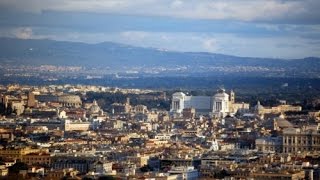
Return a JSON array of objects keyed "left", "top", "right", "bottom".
[{"left": 0, "top": 27, "right": 320, "bottom": 58}]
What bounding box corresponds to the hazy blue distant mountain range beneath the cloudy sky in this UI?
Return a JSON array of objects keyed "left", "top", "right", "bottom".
[{"left": 0, "top": 38, "right": 320, "bottom": 78}]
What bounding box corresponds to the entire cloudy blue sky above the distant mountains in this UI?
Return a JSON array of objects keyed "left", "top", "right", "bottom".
[{"left": 0, "top": 0, "right": 320, "bottom": 58}]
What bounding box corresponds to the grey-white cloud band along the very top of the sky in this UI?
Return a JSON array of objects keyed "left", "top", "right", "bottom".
[{"left": 0, "top": 0, "right": 320, "bottom": 21}]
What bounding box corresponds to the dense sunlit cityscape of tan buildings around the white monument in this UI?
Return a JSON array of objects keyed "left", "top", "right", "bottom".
[{"left": 0, "top": 84, "right": 320, "bottom": 179}]
